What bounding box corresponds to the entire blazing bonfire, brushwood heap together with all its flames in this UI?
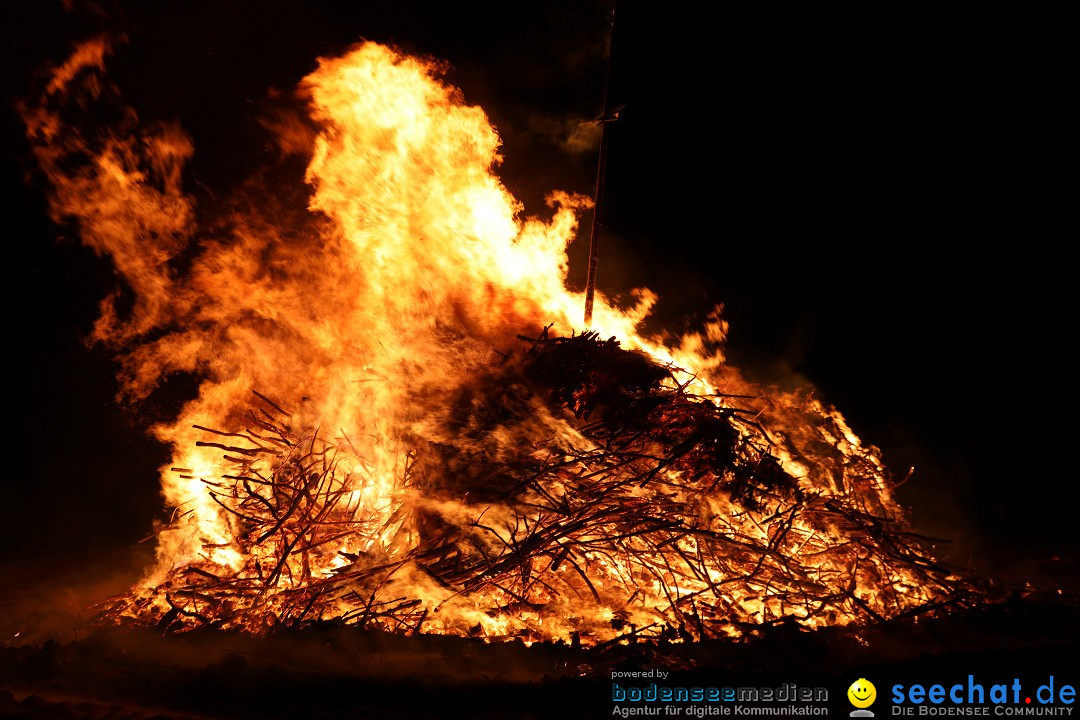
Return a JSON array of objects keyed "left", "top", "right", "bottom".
[{"left": 24, "top": 40, "right": 962, "bottom": 643}]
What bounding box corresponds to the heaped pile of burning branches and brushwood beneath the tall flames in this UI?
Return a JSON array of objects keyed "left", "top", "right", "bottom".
[{"left": 103, "top": 331, "right": 976, "bottom": 646}]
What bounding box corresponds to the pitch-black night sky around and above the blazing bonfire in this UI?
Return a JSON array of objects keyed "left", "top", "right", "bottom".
[{"left": 0, "top": 1, "right": 1080, "bottom": 604}]
